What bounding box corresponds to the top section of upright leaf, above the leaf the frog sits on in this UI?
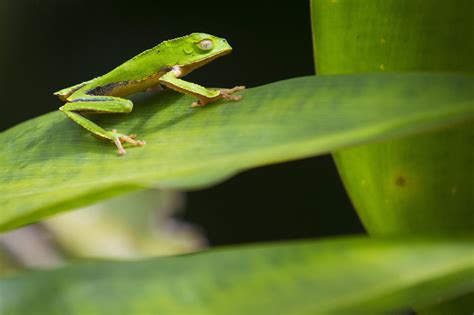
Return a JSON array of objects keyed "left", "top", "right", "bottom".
[{"left": 311, "top": 0, "right": 474, "bottom": 75}]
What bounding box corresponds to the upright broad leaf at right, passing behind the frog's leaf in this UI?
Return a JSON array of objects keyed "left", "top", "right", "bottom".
[{"left": 311, "top": 0, "right": 474, "bottom": 235}]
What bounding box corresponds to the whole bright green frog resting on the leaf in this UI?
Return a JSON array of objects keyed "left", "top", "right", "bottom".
[{"left": 54, "top": 33, "right": 244, "bottom": 155}]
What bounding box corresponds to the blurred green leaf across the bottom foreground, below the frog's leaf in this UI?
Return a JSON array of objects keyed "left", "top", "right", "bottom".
[{"left": 0, "top": 237, "right": 474, "bottom": 315}]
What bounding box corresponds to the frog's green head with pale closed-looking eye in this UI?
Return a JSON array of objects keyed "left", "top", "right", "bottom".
[{"left": 174, "top": 33, "right": 232, "bottom": 75}]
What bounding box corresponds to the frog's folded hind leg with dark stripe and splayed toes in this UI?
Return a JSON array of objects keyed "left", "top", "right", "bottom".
[{"left": 60, "top": 95, "right": 145, "bottom": 155}]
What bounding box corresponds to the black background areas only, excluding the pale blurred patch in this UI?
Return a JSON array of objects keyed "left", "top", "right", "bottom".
[{"left": 0, "top": 0, "right": 363, "bottom": 245}]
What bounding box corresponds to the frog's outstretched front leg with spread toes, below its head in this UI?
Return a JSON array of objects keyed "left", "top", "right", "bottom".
[{"left": 160, "top": 68, "right": 245, "bottom": 107}]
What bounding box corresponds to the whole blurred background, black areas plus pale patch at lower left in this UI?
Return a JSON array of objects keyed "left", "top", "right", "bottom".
[{"left": 0, "top": 0, "right": 364, "bottom": 272}]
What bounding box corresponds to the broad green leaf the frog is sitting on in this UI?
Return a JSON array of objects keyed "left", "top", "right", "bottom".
[{"left": 0, "top": 74, "right": 474, "bottom": 230}]
